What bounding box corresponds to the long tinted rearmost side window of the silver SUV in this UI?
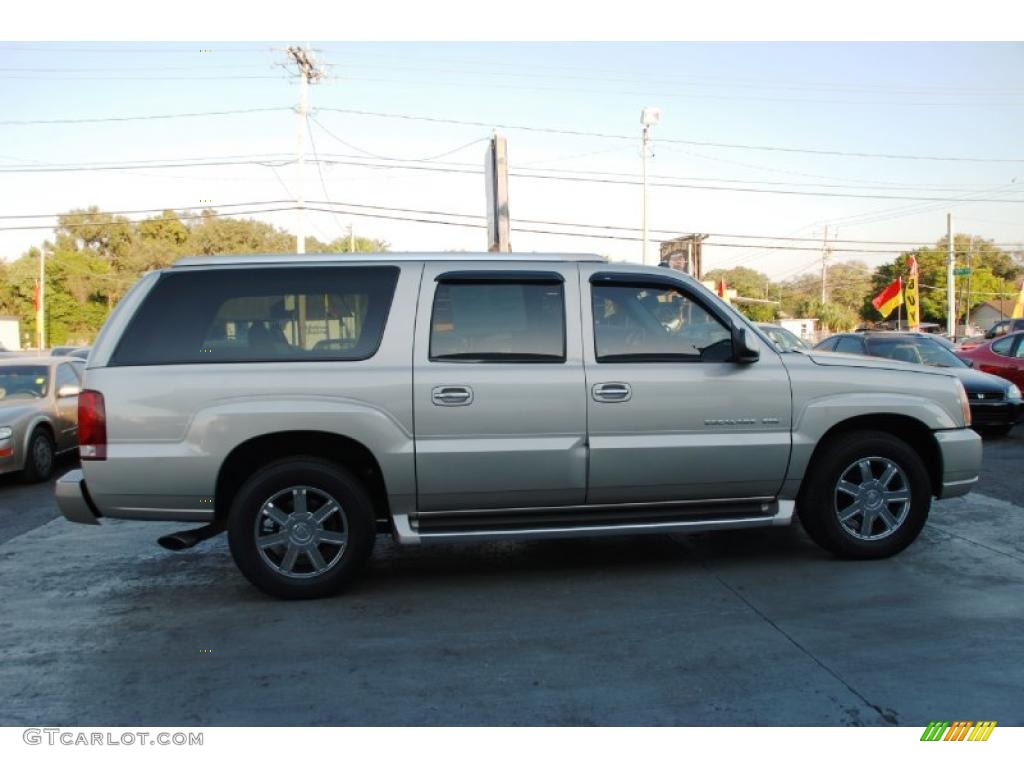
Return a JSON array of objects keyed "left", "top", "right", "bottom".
[{"left": 111, "top": 266, "right": 398, "bottom": 366}]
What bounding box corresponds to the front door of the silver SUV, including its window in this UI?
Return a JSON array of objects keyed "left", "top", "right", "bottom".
[{"left": 581, "top": 265, "right": 792, "bottom": 504}]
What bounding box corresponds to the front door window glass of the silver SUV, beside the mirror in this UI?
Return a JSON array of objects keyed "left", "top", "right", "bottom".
[{"left": 591, "top": 285, "right": 732, "bottom": 362}]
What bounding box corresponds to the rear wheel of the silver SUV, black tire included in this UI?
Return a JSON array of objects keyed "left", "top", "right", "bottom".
[{"left": 227, "top": 456, "right": 377, "bottom": 599}]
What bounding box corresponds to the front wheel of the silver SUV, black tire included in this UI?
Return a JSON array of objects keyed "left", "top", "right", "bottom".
[{"left": 797, "top": 431, "right": 932, "bottom": 560}]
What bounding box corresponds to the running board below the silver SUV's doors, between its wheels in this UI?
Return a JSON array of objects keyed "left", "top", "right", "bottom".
[{"left": 410, "top": 501, "right": 795, "bottom": 543}]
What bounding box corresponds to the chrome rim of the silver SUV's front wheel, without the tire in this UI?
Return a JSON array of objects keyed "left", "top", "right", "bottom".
[{"left": 835, "top": 456, "right": 910, "bottom": 541}]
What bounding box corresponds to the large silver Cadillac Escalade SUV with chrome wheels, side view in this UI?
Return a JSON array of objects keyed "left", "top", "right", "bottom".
[{"left": 57, "top": 254, "right": 981, "bottom": 597}]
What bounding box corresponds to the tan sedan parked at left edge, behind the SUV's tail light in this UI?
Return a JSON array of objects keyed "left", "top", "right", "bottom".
[{"left": 0, "top": 356, "right": 85, "bottom": 481}]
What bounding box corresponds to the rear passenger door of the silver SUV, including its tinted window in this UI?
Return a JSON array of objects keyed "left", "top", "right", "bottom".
[{"left": 413, "top": 262, "right": 587, "bottom": 511}]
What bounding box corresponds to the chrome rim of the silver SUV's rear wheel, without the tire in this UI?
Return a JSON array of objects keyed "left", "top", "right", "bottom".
[{"left": 253, "top": 485, "right": 348, "bottom": 579}]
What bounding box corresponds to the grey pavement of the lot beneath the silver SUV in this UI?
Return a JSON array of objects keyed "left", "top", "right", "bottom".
[{"left": 0, "top": 427, "right": 1024, "bottom": 726}]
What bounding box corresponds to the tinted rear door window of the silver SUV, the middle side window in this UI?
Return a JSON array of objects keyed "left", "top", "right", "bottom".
[{"left": 430, "top": 279, "right": 565, "bottom": 362}]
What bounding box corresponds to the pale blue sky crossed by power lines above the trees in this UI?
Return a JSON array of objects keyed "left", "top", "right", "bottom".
[{"left": 0, "top": 41, "right": 1024, "bottom": 279}]
